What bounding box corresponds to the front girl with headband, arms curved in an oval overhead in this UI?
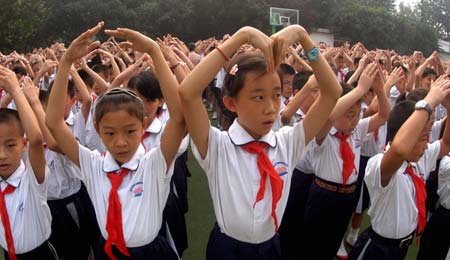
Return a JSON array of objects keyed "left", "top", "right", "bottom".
[{"left": 46, "top": 22, "right": 185, "bottom": 259}]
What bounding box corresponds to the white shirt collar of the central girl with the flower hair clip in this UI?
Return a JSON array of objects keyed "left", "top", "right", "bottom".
[{"left": 228, "top": 119, "right": 277, "bottom": 148}]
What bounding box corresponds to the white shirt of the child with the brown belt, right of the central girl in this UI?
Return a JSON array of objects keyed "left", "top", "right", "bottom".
[{"left": 312, "top": 117, "right": 370, "bottom": 184}]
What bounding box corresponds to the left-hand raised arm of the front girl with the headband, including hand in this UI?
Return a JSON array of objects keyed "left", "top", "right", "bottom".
[{"left": 46, "top": 22, "right": 103, "bottom": 166}]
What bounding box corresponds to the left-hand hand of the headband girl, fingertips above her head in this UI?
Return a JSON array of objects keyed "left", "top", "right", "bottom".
[{"left": 63, "top": 22, "right": 104, "bottom": 64}]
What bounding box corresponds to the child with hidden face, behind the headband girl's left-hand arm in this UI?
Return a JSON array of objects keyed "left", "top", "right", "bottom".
[{"left": 22, "top": 78, "right": 99, "bottom": 259}]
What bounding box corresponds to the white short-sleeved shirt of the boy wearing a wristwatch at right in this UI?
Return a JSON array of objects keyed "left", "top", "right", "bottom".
[{"left": 364, "top": 142, "right": 440, "bottom": 239}]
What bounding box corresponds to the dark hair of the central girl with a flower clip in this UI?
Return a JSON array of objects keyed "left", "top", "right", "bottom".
[{"left": 222, "top": 51, "right": 281, "bottom": 97}]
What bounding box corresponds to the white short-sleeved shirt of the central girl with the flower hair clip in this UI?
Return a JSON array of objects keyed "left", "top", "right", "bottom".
[{"left": 192, "top": 120, "right": 305, "bottom": 244}]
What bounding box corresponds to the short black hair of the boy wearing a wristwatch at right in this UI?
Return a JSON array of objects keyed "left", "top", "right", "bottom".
[{"left": 387, "top": 100, "right": 416, "bottom": 142}]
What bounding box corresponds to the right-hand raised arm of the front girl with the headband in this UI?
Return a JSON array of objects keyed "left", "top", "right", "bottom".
[{"left": 105, "top": 28, "right": 186, "bottom": 167}]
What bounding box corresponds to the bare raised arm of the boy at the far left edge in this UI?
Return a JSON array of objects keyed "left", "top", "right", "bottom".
[{"left": 0, "top": 66, "right": 46, "bottom": 183}]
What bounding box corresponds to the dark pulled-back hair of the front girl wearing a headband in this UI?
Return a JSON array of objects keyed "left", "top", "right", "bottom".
[{"left": 94, "top": 88, "right": 145, "bottom": 125}]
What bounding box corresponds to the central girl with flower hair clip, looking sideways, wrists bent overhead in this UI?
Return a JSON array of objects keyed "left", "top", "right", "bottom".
[{"left": 180, "top": 25, "right": 341, "bottom": 259}]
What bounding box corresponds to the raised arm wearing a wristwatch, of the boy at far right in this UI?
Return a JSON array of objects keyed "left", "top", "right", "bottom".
[{"left": 380, "top": 77, "right": 450, "bottom": 187}]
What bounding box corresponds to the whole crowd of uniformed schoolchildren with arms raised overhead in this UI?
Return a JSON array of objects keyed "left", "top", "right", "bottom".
[{"left": 0, "top": 22, "right": 450, "bottom": 260}]
